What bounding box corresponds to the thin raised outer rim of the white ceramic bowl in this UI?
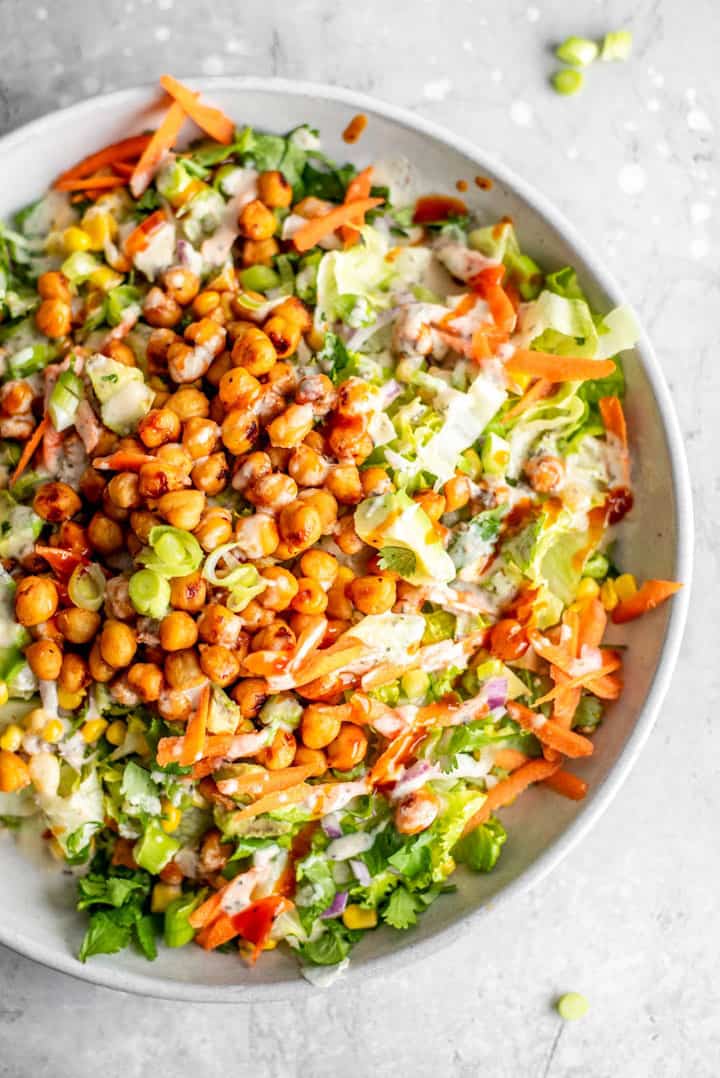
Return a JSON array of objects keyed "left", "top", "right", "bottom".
[{"left": 0, "top": 75, "right": 694, "bottom": 1003}]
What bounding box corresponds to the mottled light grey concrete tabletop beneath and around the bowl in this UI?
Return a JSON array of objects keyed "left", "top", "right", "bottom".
[{"left": 0, "top": 0, "right": 720, "bottom": 1078}]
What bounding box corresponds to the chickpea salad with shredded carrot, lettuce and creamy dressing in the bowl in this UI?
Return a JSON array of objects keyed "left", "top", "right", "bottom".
[{"left": 0, "top": 75, "right": 679, "bottom": 969}]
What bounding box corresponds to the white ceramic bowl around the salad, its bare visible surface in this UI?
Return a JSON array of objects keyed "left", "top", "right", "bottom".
[{"left": 0, "top": 79, "right": 692, "bottom": 1001}]
